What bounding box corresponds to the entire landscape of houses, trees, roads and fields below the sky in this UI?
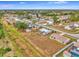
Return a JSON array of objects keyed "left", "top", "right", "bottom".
[{"left": 0, "top": 10, "right": 79, "bottom": 57}]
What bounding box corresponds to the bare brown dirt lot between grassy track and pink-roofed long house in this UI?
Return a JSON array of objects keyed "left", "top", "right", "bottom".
[{"left": 22, "top": 31, "right": 64, "bottom": 56}]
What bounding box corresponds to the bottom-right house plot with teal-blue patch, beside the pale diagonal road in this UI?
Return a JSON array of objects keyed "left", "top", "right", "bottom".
[{"left": 63, "top": 40, "right": 79, "bottom": 57}]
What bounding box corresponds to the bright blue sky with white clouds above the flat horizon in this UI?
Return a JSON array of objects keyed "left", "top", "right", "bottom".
[{"left": 0, "top": 1, "right": 79, "bottom": 10}]
